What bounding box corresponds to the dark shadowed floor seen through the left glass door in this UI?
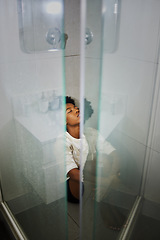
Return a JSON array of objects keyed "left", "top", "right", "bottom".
[{"left": 15, "top": 199, "right": 66, "bottom": 240}]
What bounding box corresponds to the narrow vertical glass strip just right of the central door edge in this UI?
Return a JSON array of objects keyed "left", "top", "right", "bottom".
[{"left": 81, "top": 0, "right": 102, "bottom": 240}]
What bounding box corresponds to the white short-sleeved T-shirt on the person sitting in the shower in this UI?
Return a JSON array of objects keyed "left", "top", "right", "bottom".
[{"left": 54, "top": 128, "right": 115, "bottom": 181}]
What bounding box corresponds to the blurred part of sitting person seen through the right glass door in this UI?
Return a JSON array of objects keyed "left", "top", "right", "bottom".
[{"left": 82, "top": 96, "right": 127, "bottom": 239}]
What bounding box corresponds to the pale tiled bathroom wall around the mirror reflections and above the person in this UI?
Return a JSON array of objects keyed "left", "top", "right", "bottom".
[{"left": 0, "top": 0, "right": 160, "bottom": 205}]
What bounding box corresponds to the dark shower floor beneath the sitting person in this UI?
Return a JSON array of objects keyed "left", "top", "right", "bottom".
[{"left": 5, "top": 181, "right": 133, "bottom": 240}]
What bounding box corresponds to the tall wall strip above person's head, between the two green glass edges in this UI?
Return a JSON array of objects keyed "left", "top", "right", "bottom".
[{"left": 65, "top": 0, "right": 102, "bottom": 128}]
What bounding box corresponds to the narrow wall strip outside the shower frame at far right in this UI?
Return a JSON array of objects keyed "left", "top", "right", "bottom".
[{"left": 145, "top": 63, "right": 160, "bottom": 203}]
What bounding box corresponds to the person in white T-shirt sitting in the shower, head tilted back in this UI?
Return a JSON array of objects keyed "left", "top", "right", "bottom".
[{"left": 60, "top": 97, "right": 127, "bottom": 237}]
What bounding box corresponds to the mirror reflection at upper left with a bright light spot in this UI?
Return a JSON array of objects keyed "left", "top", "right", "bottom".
[{"left": 17, "top": 0, "right": 64, "bottom": 53}]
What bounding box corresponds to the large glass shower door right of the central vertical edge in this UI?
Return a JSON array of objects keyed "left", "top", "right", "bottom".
[{"left": 82, "top": 0, "right": 159, "bottom": 239}]
